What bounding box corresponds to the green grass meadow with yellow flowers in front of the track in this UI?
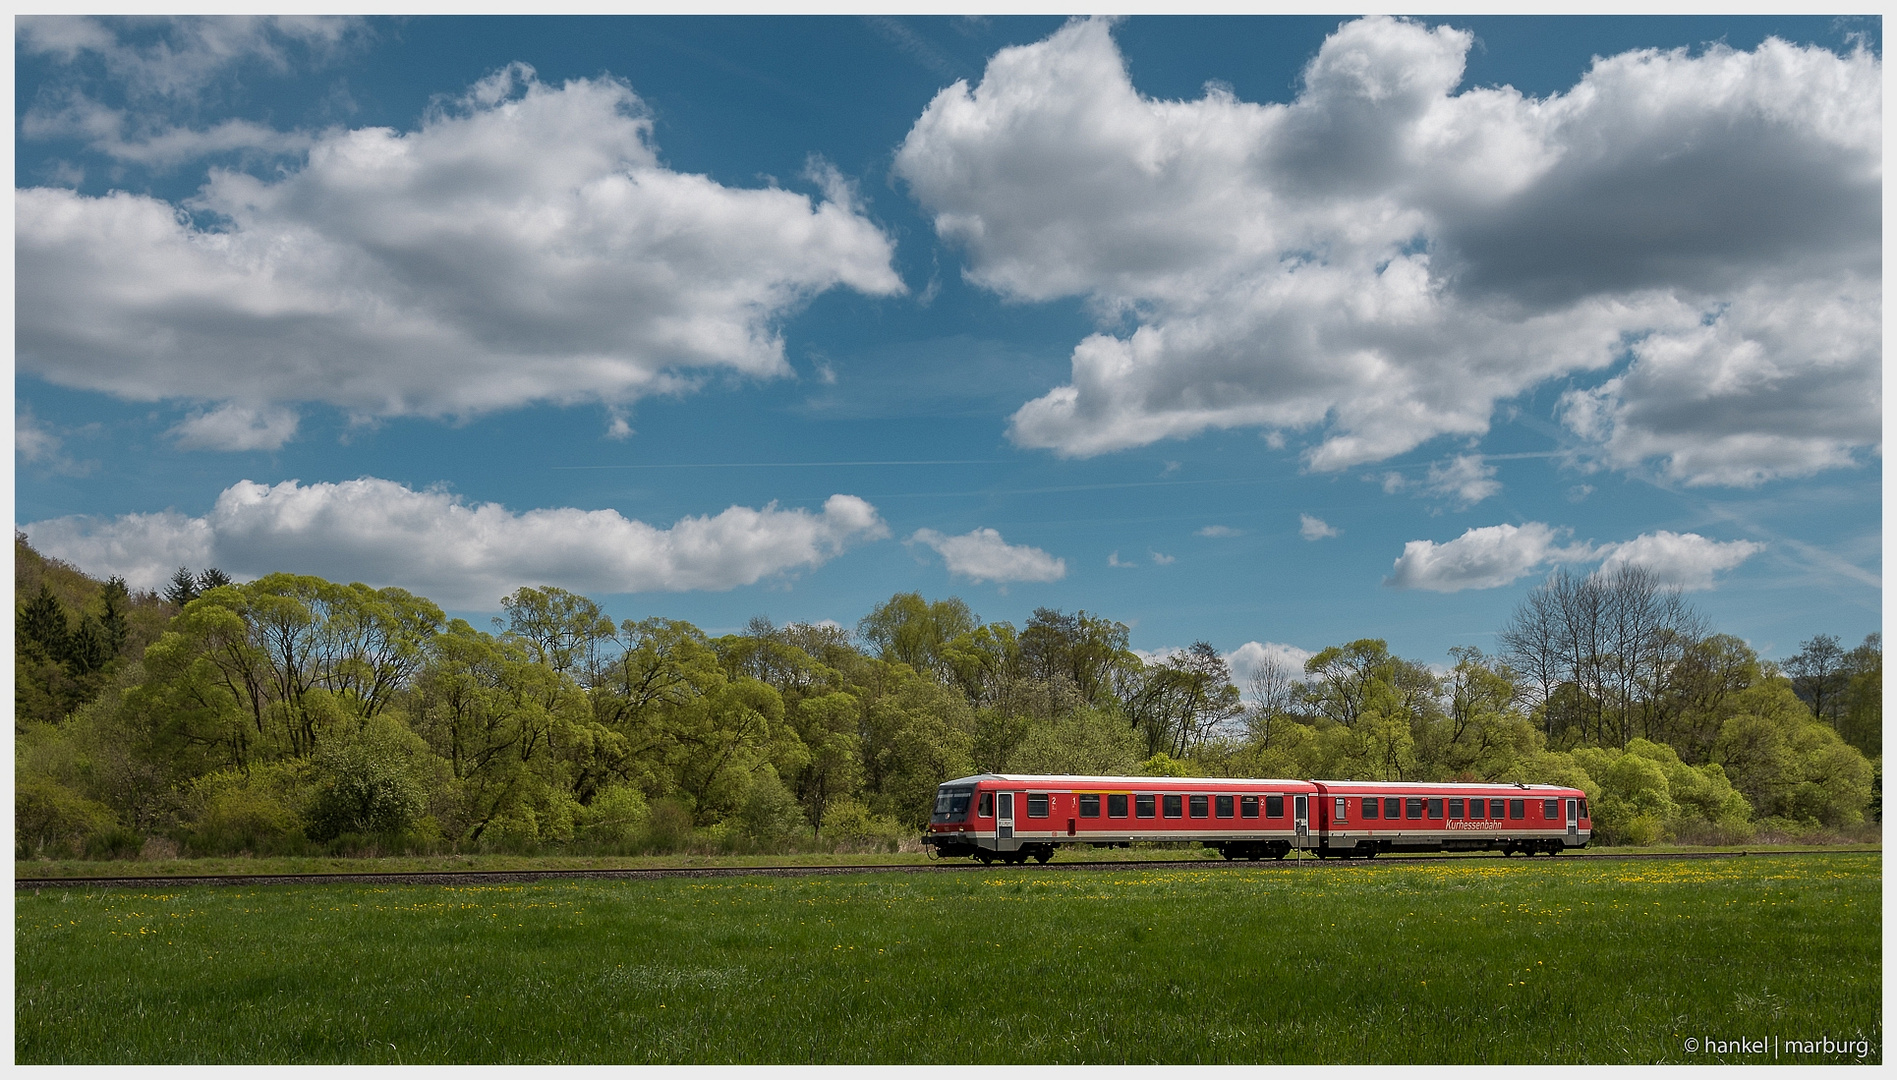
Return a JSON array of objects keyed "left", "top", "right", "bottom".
[{"left": 15, "top": 854, "right": 1882, "bottom": 1063}]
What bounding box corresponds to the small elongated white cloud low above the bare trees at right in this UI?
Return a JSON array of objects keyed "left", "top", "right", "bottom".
[{"left": 1383, "top": 522, "right": 1764, "bottom": 592}]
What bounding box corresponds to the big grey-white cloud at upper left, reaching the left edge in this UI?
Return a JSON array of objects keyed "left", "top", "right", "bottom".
[{"left": 15, "top": 65, "right": 903, "bottom": 440}]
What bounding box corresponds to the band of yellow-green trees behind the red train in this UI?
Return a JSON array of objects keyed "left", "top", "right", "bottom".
[{"left": 15, "top": 533, "right": 1884, "bottom": 860}]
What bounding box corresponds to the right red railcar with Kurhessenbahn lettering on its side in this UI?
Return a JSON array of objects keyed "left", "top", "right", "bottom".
[{"left": 1315, "top": 780, "right": 1593, "bottom": 858}]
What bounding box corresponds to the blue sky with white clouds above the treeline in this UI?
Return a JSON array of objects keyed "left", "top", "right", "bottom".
[{"left": 15, "top": 17, "right": 1882, "bottom": 666}]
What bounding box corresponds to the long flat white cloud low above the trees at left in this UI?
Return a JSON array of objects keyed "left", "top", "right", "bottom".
[{"left": 25, "top": 476, "right": 888, "bottom": 609}]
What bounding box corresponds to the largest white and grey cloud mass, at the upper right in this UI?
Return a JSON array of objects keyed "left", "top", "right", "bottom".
[{"left": 895, "top": 17, "right": 1882, "bottom": 484}]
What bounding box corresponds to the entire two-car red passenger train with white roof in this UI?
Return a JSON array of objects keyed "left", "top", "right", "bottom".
[{"left": 922, "top": 773, "right": 1592, "bottom": 864}]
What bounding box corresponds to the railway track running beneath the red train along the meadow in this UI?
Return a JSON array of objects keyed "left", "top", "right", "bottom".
[{"left": 13, "top": 850, "right": 1870, "bottom": 892}]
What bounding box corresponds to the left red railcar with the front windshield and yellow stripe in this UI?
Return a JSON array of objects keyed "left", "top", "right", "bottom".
[{"left": 922, "top": 773, "right": 1318, "bottom": 862}]
